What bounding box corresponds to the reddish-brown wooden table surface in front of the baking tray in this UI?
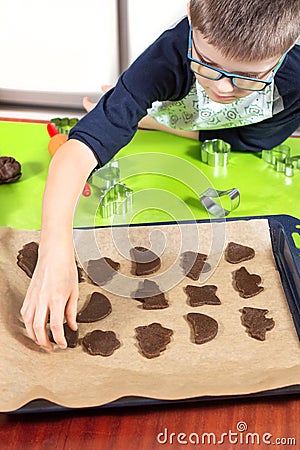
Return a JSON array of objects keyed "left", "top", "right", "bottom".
[{"left": 0, "top": 394, "right": 300, "bottom": 450}]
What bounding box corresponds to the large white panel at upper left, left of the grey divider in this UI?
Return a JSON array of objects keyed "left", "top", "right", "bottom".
[{"left": 0, "top": 0, "right": 119, "bottom": 106}]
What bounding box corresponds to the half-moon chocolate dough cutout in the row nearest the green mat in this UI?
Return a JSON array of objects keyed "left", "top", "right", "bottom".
[{"left": 130, "top": 247, "right": 161, "bottom": 277}]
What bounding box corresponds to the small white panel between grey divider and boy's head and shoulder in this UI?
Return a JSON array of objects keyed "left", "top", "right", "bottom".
[{"left": 127, "top": 0, "right": 188, "bottom": 62}]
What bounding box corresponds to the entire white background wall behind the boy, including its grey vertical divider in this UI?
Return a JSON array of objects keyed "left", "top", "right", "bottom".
[{"left": 0, "top": 0, "right": 187, "bottom": 107}]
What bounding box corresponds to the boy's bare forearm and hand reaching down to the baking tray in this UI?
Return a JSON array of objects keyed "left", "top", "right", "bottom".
[{"left": 21, "top": 139, "right": 97, "bottom": 350}]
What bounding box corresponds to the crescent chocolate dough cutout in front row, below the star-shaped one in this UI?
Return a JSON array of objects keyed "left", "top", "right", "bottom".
[{"left": 187, "top": 313, "right": 219, "bottom": 344}]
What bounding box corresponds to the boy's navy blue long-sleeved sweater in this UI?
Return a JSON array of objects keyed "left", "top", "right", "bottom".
[{"left": 69, "top": 18, "right": 300, "bottom": 166}]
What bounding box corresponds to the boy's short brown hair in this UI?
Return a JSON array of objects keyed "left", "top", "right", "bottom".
[{"left": 190, "top": 0, "right": 300, "bottom": 61}]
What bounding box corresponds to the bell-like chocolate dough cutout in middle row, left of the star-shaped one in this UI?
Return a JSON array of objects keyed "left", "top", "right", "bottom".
[{"left": 133, "top": 279, "right": 169, "bottom": 310}]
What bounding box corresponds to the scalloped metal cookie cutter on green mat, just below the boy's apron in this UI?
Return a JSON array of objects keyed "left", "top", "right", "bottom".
[{"left": 200, "top": 139, "right": 231, "bottom": 167}]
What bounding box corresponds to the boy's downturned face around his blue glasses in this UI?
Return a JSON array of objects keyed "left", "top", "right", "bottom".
[{"left": 192, "top": 30, "right": 282, "bottom": 103}]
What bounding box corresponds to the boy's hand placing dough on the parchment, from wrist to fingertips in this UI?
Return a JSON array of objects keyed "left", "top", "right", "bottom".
[{"left": 21, "top": 243, "right": 78, "bottom": 351}]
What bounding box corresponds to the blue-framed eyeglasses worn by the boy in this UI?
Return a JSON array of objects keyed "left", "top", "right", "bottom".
[{"left": 187, "top": 26, "right": 287, "bottom": 91}]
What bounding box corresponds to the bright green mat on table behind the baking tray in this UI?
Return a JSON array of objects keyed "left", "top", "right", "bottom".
[{"left": 0, "top": 121, "right": 300, "bottom": 229}]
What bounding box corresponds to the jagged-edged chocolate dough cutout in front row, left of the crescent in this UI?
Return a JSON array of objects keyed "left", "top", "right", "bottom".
[{"left": 135, "top": 322, "right": 173, "bottom": 359}]
